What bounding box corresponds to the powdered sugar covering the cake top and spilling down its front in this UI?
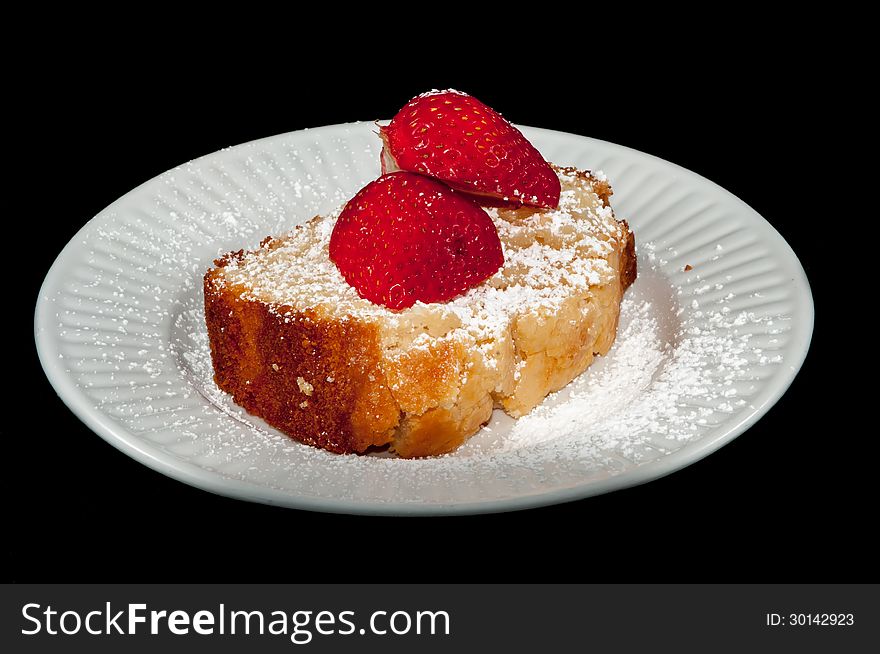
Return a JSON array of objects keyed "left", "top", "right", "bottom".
[{"left": 213, "top": 169, "right": 626, "bottom": 391}]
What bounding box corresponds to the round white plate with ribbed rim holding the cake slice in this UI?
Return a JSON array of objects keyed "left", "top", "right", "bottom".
[{"left": 35, "top": 123, "right": 813, "bottom": 514}]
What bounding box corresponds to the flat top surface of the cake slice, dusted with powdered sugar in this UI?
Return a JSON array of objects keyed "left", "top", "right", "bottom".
[{"left": 216, "top": 167, "right": 623, "bottom": 332}]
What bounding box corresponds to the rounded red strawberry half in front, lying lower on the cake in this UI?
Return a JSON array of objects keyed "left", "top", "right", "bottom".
[{"left": 330, "top": 172, "right": 504, "bottom": 310}]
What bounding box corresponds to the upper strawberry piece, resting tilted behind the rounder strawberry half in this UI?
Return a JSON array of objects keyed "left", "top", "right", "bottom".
[{"left": 379, "top": 90, "right": 559, "bottom": 208}]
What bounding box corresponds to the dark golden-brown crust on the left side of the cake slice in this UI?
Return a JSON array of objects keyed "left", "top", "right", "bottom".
[{"left": 204, "top": 270, "right": 400, "bottom": 453}]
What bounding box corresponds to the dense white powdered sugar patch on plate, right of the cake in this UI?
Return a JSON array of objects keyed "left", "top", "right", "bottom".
[{"left": 504, "top": 299, "right": 761, "bottom": 457}]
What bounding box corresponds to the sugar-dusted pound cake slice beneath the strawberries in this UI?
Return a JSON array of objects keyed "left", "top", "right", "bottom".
[{"left": 204, "top": 167, "right": 636, "bottom": 457}]
